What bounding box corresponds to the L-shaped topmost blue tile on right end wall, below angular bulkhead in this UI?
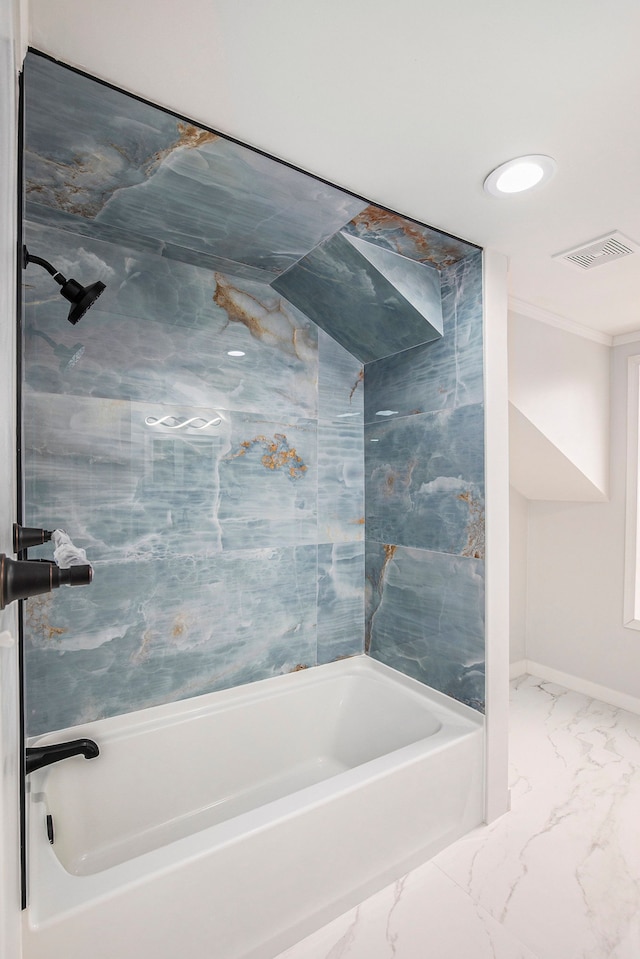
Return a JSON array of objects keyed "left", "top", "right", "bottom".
[{"left": 365, "top": 254, "right": 483, "bottom": 423}]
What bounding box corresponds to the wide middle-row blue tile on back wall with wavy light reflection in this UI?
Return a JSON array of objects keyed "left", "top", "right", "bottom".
[{"left": 24, "top": 393, "right": 317, "bottom": 560}]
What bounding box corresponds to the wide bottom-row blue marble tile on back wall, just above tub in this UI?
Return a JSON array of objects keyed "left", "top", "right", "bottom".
[{"left": 25, "top": 546, "right": 317, "bottom": 735}]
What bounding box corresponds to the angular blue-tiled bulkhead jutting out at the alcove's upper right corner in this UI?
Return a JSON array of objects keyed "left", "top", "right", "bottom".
[{"left": 271, "top": 233, "right": 442, "bottom": 363}]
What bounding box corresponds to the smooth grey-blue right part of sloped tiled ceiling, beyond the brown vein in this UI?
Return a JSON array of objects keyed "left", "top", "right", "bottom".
[{"left": 96, "top": 138, "right": 364, "bottom": 274}]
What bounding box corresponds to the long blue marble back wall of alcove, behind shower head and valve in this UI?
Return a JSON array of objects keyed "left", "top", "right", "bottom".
[{"left": 23, "top": 222, "right": 364, "bottom": 734}]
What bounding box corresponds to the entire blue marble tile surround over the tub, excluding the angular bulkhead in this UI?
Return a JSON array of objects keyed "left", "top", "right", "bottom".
[{"left": 22, "top": 53, "right": 483, "bottom": 734}]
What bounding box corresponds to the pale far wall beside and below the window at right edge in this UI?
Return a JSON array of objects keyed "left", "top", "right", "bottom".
[{"left": 527, "top": 335, "right": 640, "bottom": 701}]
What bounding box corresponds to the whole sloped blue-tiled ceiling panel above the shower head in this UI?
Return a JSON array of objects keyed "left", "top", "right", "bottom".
[{"left": 25, "top": 55, "right": 366, "bottom": 273}]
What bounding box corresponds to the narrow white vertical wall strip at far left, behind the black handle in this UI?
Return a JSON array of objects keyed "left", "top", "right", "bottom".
[{"left": 0, "top": 0, "right": 24, "bottom": 959}]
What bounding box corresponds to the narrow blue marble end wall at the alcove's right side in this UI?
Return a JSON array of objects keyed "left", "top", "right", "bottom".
[{"left": 365, "top": 253, "right": 485, "bottom": 710}]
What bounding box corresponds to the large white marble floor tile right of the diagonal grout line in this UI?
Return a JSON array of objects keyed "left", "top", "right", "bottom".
[{"left": 439, "top": 677, "right": 640, "bottom": 959}]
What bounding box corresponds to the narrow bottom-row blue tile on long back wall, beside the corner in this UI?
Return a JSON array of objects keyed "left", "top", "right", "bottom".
[{"left": 318, "top": 543, "right": 364, "bottom": 663}]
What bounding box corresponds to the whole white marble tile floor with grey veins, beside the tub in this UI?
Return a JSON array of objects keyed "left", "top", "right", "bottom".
[{"left": 280, "top": 676, "right": 640, "bottom": 959}]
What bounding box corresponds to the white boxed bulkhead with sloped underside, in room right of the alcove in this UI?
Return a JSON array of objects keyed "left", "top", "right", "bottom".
[{"left": 509, "top": 312, "right": 610, "bottom": 500}]
